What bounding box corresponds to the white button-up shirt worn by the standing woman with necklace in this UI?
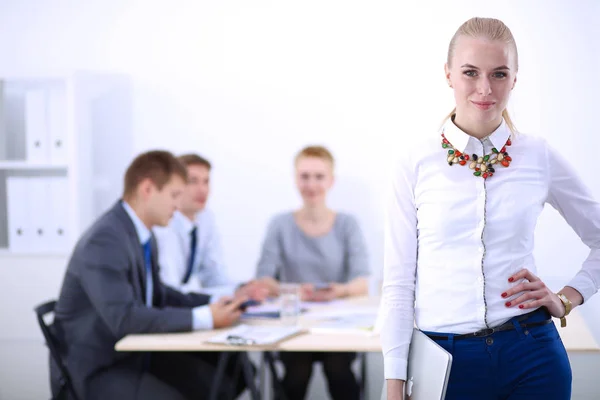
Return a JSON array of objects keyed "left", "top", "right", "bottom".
[{"left": 381, "top": 121, "right": 600, "bottom": 379}]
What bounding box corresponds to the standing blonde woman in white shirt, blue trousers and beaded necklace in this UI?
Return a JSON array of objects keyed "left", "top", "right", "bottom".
[{"left": 381, "top": 18, "right": 600, "bottom": 400}]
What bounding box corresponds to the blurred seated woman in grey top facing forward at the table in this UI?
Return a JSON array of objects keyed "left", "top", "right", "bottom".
[{"left": 257, "top": 146, "right": 369, "bottom": 400}]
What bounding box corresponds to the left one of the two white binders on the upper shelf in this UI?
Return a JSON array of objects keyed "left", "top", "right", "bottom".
[{"left": 25, "top": 90, "right": 49, "bottom": 163}]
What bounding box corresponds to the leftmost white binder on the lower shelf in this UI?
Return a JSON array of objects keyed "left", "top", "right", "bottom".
[{"left": 6, "top": 176, "right": 33, "bottom": 252}]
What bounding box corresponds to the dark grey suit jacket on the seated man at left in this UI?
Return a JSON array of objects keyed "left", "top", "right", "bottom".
[{"left": 51, "top": 201, "right": 209, "bottom": 399}]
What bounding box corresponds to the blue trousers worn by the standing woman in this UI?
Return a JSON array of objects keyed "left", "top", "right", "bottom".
[{"left": 424, "top": 308, "right": 572, "bottom": 400}]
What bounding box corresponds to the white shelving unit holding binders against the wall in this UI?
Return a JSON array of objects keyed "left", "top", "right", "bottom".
[{"left": 0, "top": 73, "right": 132, "bottom": 257}]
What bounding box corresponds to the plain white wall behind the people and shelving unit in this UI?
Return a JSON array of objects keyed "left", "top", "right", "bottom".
[{"left": 0, "top": 0, "right": 600, "bottom": 399}]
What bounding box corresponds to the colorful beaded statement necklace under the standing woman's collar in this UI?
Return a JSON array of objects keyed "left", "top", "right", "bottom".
[{"left": 442, "top": 133, "right": 512, "bottom": 179}]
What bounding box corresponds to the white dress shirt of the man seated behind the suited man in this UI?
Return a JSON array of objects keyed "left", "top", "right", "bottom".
[{"left": 154, "top": 210, "right": 236, "bottom": 301}]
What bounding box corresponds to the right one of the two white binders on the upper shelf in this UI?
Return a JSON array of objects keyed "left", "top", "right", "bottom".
[{"left": 48, "top": 89, "right": 69, "bottom": 164}]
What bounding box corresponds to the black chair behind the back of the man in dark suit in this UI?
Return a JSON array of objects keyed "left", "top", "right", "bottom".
[{"left": 35, "top": 301, "right": 79, "bottom": 400}]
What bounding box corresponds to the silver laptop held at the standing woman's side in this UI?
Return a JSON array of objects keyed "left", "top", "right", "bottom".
[{"left": 404, "top": 328, "right": 452, "bottom": 400}]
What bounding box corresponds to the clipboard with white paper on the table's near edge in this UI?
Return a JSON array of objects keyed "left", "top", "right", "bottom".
[{"left": 207, "top": 324, "right": 302, "bottom": 345}]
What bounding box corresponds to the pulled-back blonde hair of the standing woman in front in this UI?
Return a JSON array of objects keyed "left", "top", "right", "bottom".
[{"left": 443, "top": 17, "right": 519, "bottom": 133}]
